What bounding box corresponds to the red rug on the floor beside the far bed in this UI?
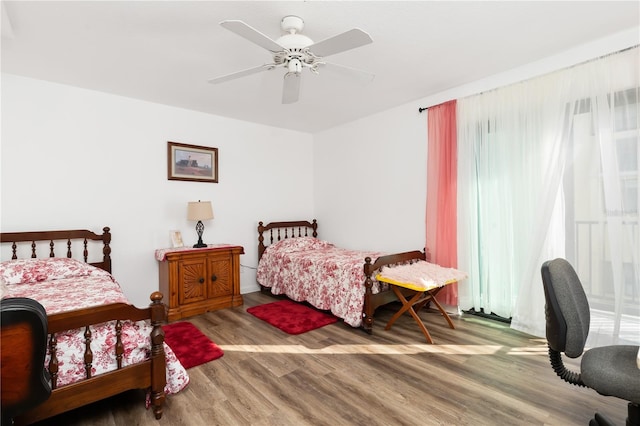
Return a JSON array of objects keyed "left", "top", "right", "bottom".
[{"left": 247, "top": 300, "right": 338, "bottom": 334}]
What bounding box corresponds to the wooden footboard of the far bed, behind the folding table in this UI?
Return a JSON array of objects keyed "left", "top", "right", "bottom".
[{"left": 362, "top": 250, "right": 427, "bottom": 334}]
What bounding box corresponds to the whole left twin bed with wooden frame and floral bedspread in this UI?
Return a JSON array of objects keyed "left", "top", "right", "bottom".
[{"left": 0, "top": 227, "right": 189, "bottom": 423}]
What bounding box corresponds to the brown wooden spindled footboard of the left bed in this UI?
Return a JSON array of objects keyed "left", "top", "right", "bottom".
[{"left": 16, "top": 292, "right": 166, "bottom": 424}]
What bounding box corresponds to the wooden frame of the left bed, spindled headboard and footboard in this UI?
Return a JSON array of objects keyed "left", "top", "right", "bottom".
[{"left": 0, "top": 227, "right": 166, "bottom": 424}]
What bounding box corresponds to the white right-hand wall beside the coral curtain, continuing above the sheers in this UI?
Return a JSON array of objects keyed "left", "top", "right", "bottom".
[{"left": 313, "top": 28, "right": 640, "bottom": 252}]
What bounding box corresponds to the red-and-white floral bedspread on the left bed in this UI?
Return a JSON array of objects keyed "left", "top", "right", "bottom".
[{"left": 0, "top": 258, "right": 189, "bottom": 394}]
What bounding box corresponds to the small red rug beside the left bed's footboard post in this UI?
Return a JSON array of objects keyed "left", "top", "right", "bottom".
[{"left": 162, "top": 321, "right": 224, "bottom": 368}]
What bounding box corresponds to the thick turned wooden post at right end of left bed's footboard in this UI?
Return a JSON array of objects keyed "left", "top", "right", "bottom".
[{"left": 150, "top": 291, "right": 167, "bottom": 420}]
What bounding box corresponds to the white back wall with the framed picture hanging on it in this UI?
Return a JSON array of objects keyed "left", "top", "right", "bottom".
[{"left": 0, "top": 74, "right": 313, "bottom": 306}]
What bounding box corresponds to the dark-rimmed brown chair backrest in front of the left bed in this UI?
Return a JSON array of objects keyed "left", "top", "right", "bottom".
[{"left": 0, "top": 297, "right": 51, "bottom": 422}]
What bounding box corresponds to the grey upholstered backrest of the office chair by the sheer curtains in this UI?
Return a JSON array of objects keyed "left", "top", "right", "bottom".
[{"left": 541, "top": 259, "right": 590, "bottom": 358}]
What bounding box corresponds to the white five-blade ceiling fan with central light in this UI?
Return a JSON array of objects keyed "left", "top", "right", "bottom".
[{"left": 209, "top": 15, "right": 374, "bottom": 104}]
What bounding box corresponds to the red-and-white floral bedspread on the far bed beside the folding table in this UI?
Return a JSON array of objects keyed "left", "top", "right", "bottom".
[{"left": 257, "top": 237, "right": 385, "bottom": 327}]
